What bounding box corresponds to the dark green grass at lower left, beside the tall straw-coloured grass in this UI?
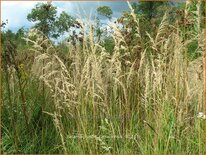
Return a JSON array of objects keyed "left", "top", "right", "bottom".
[{"left": 1, "top": 74, "right": 61, "bottom": 154}]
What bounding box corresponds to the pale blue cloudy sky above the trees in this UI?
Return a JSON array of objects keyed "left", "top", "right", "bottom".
[{"left": 1, "top": 1, "right": 128, "bottom": 32}]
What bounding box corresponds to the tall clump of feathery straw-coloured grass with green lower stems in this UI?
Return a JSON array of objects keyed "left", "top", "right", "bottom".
[{"left": 3, "top": 0, "right": 206, "bottom": 154}]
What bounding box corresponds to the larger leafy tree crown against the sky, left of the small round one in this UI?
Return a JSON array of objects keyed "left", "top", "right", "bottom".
[{"left": 27, "top": 2, "right": 75, "bottom": 38}]
